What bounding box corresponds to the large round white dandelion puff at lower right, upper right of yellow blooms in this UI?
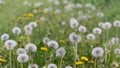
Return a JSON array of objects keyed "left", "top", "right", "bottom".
[{"left": 92, "top": 47, "right": 104, "bottom": 57}]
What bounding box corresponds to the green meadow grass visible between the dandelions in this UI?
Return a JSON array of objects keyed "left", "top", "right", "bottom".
[{"left": 0, "top": 0, "right": 120, "bottom": 68}]
